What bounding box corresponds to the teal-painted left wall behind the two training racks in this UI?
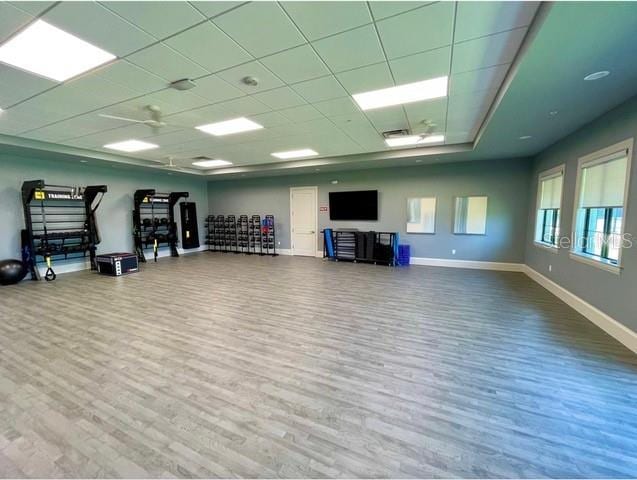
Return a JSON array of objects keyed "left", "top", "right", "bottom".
[{"left": 0, "top": 154, "right": 208, "bottom": 259}]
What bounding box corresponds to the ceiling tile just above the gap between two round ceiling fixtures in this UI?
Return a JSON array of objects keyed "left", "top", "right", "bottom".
[{"left": 165, "top": 22, "right": 252, "bottom": 72}]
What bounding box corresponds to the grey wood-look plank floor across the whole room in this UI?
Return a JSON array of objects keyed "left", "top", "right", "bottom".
[{"left": 0, "top": 253, "right": 637, "bottom": 478}]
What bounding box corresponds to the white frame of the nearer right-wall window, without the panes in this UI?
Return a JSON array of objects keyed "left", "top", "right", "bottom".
[{"left": 570, "top": 138, "right": 633, "bottom": 275}]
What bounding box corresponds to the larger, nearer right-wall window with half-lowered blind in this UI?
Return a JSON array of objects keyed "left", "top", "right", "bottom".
[{"left": 573, "top": 140, "right": 632, "bottom": 266}]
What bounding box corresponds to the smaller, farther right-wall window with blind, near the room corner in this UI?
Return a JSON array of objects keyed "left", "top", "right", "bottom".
[{"left": 535, "top": 165, "right": 564, "bottom": 248}]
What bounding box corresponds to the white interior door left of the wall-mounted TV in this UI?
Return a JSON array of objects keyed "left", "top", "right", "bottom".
[{"left": 290, "top": 187, "right": 318, "bottom": 257}]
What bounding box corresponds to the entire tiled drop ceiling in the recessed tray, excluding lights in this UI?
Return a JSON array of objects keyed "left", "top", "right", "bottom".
[{"left": 0, "top": 1, "right": 539, "bottom": 174}]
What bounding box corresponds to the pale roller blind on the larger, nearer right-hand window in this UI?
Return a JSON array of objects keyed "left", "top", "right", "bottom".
[{"left": 580, "top": 152, "right": 628, "bottom": 208}]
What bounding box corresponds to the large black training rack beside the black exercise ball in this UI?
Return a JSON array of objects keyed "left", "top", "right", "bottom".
[{"left": 22, "top": 180, "right": 108, "bottom": 280}]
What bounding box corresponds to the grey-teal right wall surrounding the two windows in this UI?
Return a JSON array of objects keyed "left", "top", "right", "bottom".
[{"left": 526, "top": 97, "right": 637, "bottom": 331}]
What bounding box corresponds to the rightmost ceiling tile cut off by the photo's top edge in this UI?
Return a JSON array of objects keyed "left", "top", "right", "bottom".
[{"left": 455, "top": 1, "right": 538, "bottom": 42}]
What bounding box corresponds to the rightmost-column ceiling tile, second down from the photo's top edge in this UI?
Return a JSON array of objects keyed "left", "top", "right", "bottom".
[{"left": 451, "top": 28, "right": 526, "bottom": 73}]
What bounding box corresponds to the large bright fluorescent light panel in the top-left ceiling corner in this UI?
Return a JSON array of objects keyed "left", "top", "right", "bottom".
[{"left": 0, "top": 20, "right": 116, "bottom": 82}]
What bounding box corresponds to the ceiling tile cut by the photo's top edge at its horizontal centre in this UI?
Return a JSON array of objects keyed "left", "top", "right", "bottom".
[{"left": 283, "top": 1, "right": 372, "bottom": 41}]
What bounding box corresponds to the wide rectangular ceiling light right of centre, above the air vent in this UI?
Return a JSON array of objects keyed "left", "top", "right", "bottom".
[{"left": 352, "top": 76, "right": 448, "bottom": 110}]
